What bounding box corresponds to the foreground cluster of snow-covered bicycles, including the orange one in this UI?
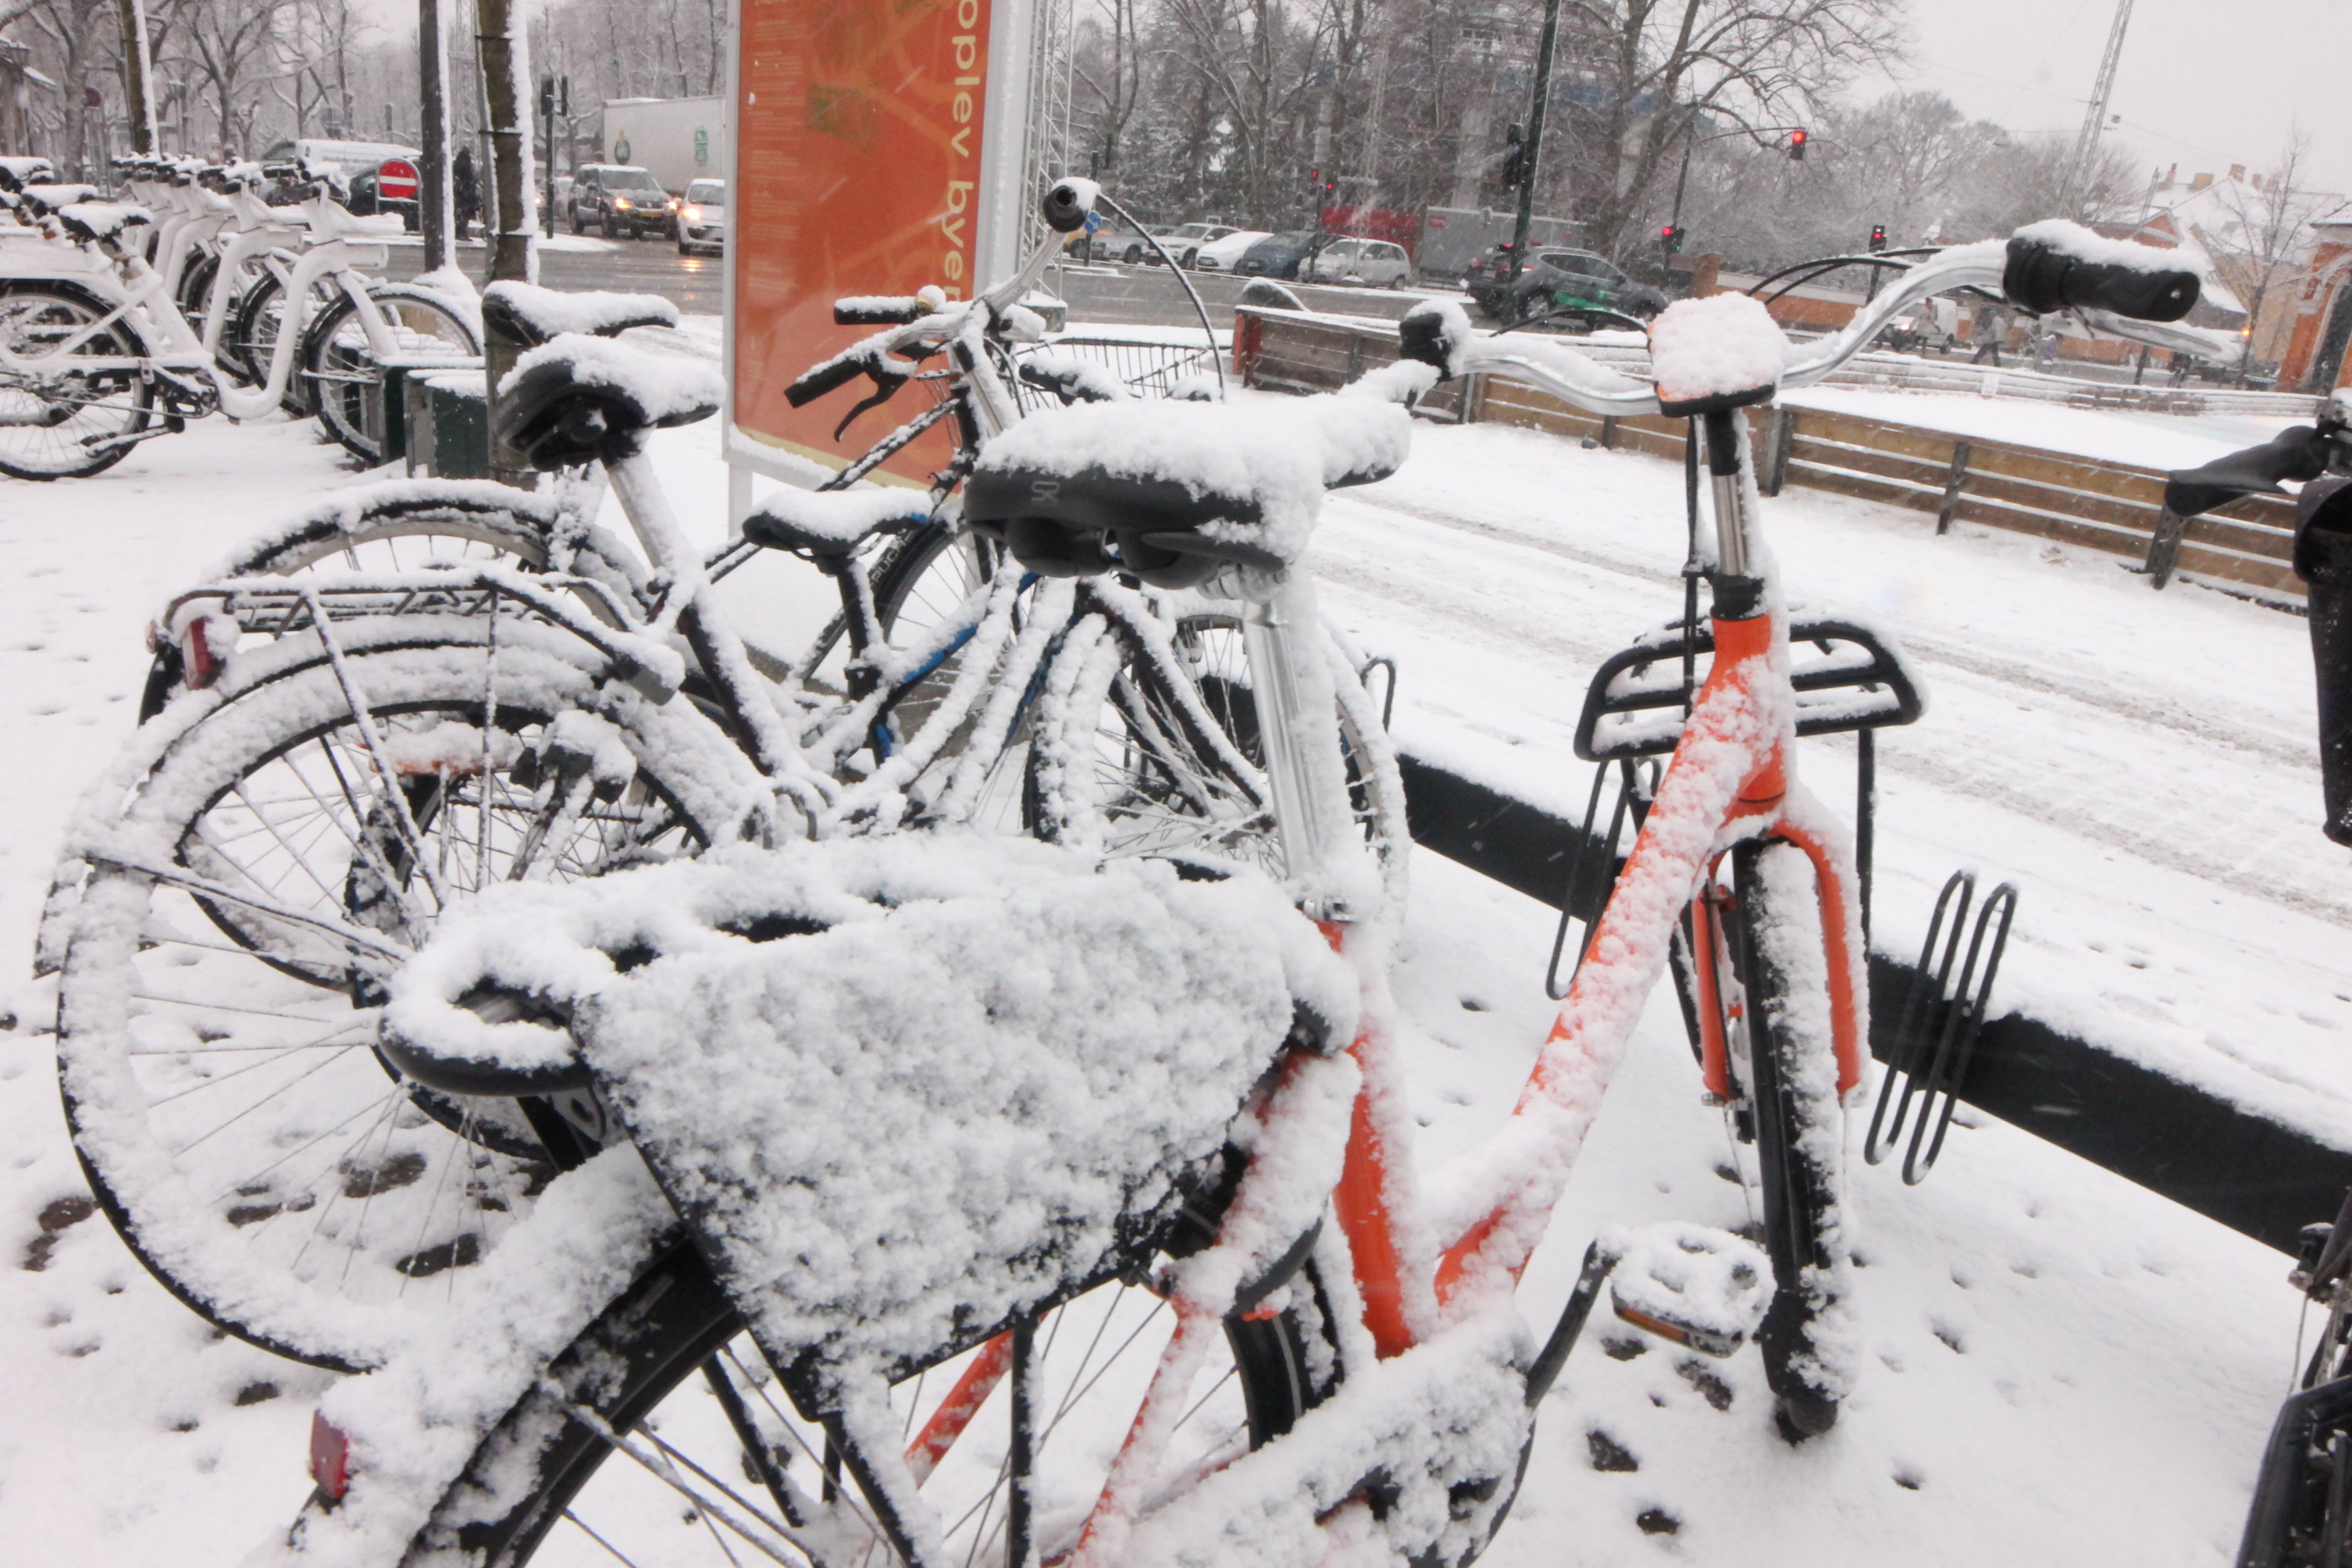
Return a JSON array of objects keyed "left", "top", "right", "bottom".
[{"left": 35, "top": 165, "right": 2352, "bottom": 1568}]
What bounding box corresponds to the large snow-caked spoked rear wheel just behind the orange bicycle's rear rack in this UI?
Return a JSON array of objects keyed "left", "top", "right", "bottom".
[{"left": 56, "top": 639, "right": 757, "bottom": 1368}]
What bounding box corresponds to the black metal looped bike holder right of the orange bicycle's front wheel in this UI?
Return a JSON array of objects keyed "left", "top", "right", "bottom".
[{"left": 1863, "top": 872, "right": 2018, "bottom": 1187}]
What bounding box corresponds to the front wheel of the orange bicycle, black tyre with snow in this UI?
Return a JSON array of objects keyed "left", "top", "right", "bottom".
[{"left": 1727, "top": 839, "right": 1851, "bottom": 1437}]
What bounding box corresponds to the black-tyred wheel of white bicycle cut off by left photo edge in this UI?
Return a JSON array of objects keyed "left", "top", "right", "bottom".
[{"left": 0, "top": 278, "right": 155, "bottom": 480}]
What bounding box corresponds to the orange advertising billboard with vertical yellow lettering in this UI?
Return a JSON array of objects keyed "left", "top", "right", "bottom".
[{"left": 727, "top": 0, "right": 1002, "bottom": 480}]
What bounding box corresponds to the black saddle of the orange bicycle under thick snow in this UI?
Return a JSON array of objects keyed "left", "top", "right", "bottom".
[{"left": 964, "top": 397, "right": 1411, "bottom": 588}]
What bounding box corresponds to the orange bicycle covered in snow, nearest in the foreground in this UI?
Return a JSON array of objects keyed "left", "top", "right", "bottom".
[{"left": 225, "top": 211, "right": 2194, "bottom": 1566}]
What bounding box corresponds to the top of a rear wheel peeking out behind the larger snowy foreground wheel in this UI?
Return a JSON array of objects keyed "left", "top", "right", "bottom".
[{"left": 139, "top": 480, "right": 644, "bottom": 724}]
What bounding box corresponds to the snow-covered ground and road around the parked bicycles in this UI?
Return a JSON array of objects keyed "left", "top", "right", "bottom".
[{"left": 0, "top": 371, "right": 2352, "bottom": 1568}]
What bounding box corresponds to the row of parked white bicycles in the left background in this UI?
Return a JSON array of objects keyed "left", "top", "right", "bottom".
[{"left": 0, "top": 157, "right": 482, "bottom": 480}]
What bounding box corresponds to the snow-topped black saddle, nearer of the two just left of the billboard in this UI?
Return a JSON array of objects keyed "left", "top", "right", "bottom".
[{"left": 499, "top": 331, "right": 727, "bottom": 472}]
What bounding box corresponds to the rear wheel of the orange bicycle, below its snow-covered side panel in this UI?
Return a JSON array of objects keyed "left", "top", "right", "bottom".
[{"left": 404, "top": 1243, "right": 1343, "bottom": 1568}]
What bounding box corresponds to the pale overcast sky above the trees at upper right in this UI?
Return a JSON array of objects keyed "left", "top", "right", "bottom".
[{"left": 1856, "top": 0, "right": 2352, "bottom": 193}]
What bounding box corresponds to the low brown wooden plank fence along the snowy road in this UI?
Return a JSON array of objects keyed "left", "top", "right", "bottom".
[{"left": 1232, "top": 306, "right": 2307, "bottom": 604}]
